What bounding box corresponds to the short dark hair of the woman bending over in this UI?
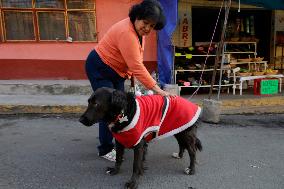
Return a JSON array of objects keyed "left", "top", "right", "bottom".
[{"left": 128, "top": 0, "right": 166, "bottom": 30}]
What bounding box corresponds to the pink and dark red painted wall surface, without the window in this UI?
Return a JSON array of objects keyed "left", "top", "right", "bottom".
[{"left": 0, "top": 0, "right": 157, "bottom": 79}]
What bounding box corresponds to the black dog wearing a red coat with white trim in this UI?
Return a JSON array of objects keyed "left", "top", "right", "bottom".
[{"left": 79, "top": 87, "right": 202, "bottom": 188}]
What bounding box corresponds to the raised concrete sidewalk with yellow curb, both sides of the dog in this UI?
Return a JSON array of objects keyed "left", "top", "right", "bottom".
[{"left": 0, "top": 80, "right": 284, "bottom": 114}]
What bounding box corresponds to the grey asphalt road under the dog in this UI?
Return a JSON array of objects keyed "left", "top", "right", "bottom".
[{"left": 0, "top": 114, "right": 284, "bottom": 189}]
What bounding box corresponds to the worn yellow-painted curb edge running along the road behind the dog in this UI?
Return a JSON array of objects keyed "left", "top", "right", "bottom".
[{"left": 0, "top": 96, "right": 284, "bottom": 115}]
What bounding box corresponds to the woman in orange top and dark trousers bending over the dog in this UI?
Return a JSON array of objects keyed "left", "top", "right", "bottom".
[{"left": 86, "top": 0, "right": 174, "bottom": 161}]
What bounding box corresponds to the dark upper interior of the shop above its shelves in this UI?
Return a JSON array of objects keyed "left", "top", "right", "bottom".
[{"left": 192, "top": 7, "right": 272, "bottom": 60}]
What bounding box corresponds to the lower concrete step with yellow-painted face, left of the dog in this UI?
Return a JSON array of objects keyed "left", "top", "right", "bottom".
[{"left": 0, "top": 95, "right": 89, "bottom": 115}]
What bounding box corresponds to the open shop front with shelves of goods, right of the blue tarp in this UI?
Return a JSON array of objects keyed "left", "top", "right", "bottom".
[{"left": 174, "top": 6, "right": 282, "bottom": 94}]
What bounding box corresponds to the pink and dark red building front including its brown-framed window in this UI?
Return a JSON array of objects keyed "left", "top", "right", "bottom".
[{"left": 0, "top": 0, "right": 157, "bottom": 80}]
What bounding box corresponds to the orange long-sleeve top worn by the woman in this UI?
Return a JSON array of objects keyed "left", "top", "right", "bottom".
[{"left": 95, "top": 18, "right": 156, "bottom": 89}]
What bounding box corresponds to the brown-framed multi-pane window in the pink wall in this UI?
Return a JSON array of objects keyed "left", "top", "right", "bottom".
[{"left": 0, "top": 0, "right": 97, "bottom": 42}]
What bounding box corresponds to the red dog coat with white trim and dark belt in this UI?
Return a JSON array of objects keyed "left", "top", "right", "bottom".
[{"left": 112, "top": 95, "right": 201, "bottom": 148}]
